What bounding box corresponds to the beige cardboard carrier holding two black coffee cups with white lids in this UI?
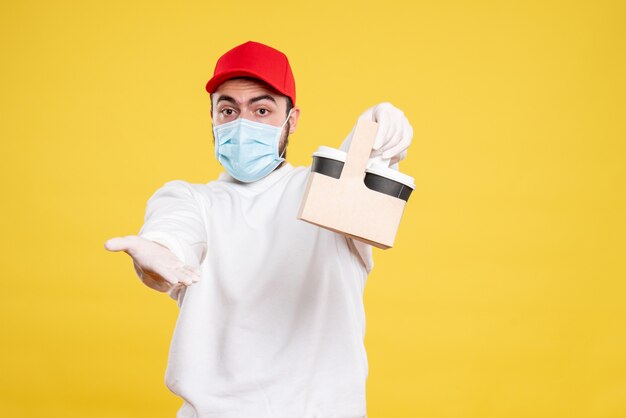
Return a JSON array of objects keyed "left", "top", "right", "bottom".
[{"left": 298, "top": 119, "right": 415, "bottom": 249}]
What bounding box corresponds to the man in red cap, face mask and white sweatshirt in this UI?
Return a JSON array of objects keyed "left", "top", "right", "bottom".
[{"left": 105, "top": 42, "right": 413, "bottom": 418}]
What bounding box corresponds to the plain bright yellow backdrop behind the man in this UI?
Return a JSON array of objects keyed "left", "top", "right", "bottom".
[{"left": 0, "top": 0, "right": 626, "bottom": 418}]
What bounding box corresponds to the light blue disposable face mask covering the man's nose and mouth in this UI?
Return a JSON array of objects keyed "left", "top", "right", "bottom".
[{"left": 213, "top": 109, "right": 293, "bottom": 183}]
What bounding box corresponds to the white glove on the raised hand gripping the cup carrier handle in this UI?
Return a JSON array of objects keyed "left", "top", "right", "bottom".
[{"left": 341, "top": 103, "right": 413, "bottom": 165}]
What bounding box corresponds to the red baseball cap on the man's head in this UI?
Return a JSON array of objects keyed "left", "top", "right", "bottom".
[{"left": 206, "top": 41, "right": 296, "bottom": 105}]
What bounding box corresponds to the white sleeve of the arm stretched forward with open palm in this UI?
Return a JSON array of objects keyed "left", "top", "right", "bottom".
[{"left": 139, "top": 180, "right": 207, "bottom": 267}]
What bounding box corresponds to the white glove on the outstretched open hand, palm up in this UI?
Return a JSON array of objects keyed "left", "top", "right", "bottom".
[{"left": 104, "top": 235, "right": 200, "bottom": 292}]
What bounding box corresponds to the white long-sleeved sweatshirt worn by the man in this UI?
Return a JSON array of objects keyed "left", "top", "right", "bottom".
[{"left": 140, "top": 164, "right": 372, "bottom": 418}]
